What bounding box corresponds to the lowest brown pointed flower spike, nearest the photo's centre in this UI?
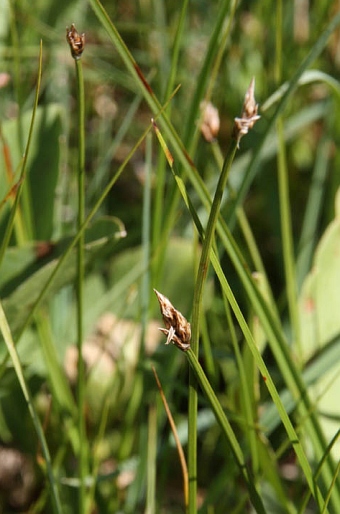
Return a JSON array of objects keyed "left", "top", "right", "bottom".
[{"left": 154, "top": 289, "right": 191, "bottom": 351}]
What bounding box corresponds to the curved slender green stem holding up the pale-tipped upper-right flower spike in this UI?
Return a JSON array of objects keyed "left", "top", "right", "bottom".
[{"left": 188, "top": 139, "right": 237, "bottom": 508}]
